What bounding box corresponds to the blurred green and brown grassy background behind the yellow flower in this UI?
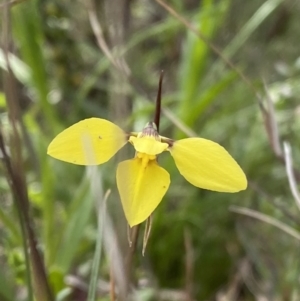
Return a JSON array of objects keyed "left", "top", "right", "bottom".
[{"left": 0, "top": 0, "right": 300, "bottom": 301}]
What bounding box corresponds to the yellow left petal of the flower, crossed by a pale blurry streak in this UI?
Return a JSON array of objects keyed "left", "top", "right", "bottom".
[{"left": 47, "top": 118, "right": 127, "bottom": 165}]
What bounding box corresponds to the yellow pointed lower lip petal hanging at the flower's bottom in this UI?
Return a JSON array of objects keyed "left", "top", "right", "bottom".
[{"left": 117, "top": 157, "right": 170, "bottom": 227}]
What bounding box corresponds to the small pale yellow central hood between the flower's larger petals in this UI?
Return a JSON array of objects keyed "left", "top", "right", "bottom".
[{"left": 129, "top": 136, "right": 169, "bottom": 155}]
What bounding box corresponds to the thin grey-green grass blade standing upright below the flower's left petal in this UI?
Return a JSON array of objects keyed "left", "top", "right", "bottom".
[{"left": 87, "top": 189, "right": 111, "bottom": 301}]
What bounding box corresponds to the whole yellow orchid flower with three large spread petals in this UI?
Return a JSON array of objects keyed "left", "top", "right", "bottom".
[{"left": 47, "top": 118, "right": 247, "bottom": 227}]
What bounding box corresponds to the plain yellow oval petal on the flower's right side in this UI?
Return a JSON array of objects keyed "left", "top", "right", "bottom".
[{"left": 169, "top": 138, "right": 247, "bottom": 192}]
